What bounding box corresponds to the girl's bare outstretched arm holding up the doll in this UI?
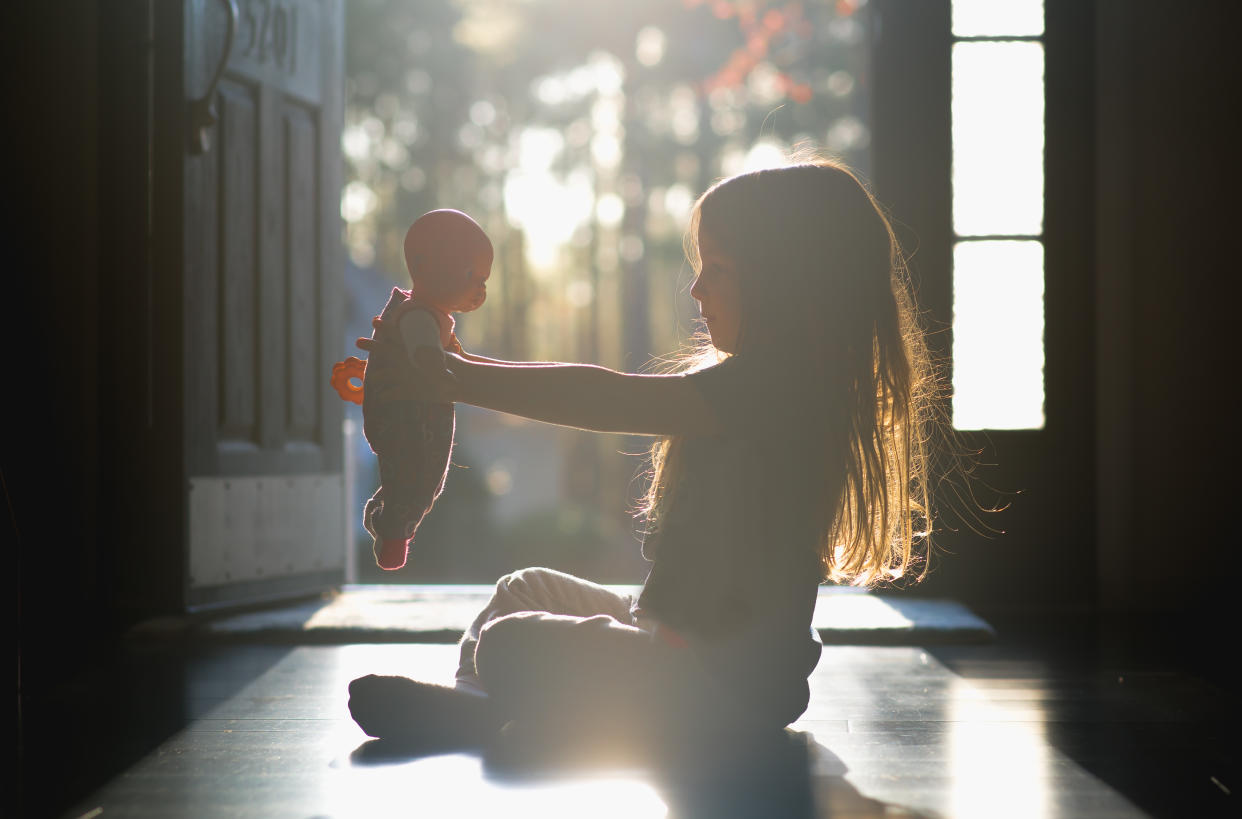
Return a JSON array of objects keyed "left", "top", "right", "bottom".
[{"left": 447, "top": 354, "right": 723, "bottom": 435}]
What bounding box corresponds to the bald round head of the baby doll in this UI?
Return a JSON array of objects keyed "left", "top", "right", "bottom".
[{"left": 405, "top": 210, "right": 493, "bottom": 313}]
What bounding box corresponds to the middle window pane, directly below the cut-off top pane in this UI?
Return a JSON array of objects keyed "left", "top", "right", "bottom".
[{"left": 953, "top": 42, "right": 1043, "bottom": 236}]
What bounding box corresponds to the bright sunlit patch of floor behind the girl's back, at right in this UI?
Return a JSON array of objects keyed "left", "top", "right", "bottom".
[{"left": 792, "top": 646, "right": 1144, "bottom": 819}]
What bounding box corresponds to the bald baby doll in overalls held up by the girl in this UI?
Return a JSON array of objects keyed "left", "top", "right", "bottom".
[{"left": 333, "top": 210, "right": 493, "bottom": 569}]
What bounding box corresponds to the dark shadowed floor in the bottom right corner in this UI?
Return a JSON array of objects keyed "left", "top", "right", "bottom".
[{"left": 928, "top": 613, "right": 1242, "bottom": 817}]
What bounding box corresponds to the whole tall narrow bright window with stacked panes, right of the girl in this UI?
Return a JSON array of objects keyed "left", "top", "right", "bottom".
[{"left": 953, "top": 0, "right": 1045, "bottom": 429}]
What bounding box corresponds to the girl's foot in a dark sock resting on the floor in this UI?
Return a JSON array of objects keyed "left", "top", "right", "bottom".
[{"left": 349, "top": 674, "right": 502, "bottom": 748}]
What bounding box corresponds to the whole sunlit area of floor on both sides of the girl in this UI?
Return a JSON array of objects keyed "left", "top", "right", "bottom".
[{"left": 70, "top": 644, "right": 1144, "bottom": 819}]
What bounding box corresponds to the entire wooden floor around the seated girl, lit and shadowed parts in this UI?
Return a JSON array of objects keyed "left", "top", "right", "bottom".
[{"left": 21, "top": 624, "right": 1242, "bottom": 819}]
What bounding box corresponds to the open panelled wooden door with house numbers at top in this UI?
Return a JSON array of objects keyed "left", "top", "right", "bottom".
[{"left": 181, "top": 0, "right": 345, "bottom": 608}]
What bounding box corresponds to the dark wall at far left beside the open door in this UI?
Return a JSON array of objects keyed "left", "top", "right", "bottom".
[{"left": 11, "top": 0, "right": 191, "bottom": 686}]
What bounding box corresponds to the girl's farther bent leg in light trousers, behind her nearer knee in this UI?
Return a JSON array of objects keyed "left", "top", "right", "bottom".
[{"left": 457, "top": 568, "right": 633, "bottom": 691}]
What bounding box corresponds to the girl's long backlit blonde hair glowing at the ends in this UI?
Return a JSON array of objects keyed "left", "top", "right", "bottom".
[{"left": 640, "top": 160, "right": 941, "bottom": 585}]
